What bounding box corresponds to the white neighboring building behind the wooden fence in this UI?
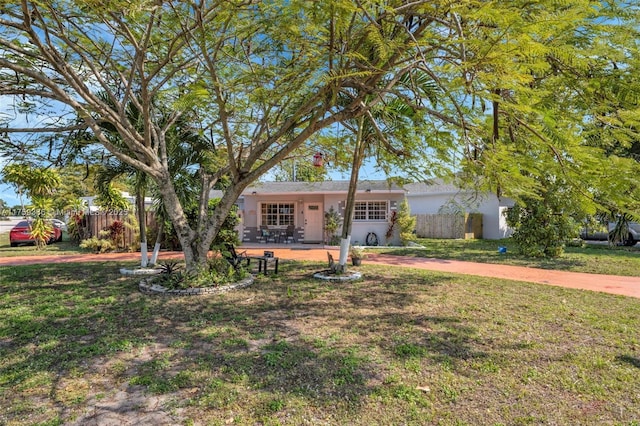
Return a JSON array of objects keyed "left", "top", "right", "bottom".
[{"left": 404, "top": 183, "right": 513, "bottom": 240}]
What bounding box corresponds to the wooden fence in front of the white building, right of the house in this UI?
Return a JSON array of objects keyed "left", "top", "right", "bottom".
[{"left": 415, "top": 213, "right": 482, "bottom": 239}]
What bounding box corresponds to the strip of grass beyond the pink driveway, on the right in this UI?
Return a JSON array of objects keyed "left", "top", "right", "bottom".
[{"left": 371, "top": 239, "right": 640, "bottom": 276}]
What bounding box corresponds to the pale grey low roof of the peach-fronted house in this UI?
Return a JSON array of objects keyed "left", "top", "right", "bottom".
[{"left": 242, "top": 180, "right": 404, "bottom": 195}]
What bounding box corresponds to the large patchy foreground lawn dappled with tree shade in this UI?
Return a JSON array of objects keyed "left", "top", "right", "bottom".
[{"left": 0, "top": 262, "right": 640, "bottom": 426}]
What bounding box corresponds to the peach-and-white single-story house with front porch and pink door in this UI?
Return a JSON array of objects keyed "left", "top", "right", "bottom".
[{"left": 238, "top": 181, "right": 405, "bottom": 245}]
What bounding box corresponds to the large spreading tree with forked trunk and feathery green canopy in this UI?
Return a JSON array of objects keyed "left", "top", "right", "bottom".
[{"left": 0, "top": 0, "right": 637, "bottom": 267}]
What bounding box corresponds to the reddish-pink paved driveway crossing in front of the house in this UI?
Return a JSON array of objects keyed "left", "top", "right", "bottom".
[{"left": 0, "top": 245, "right": 640, "bottom": 298}]
